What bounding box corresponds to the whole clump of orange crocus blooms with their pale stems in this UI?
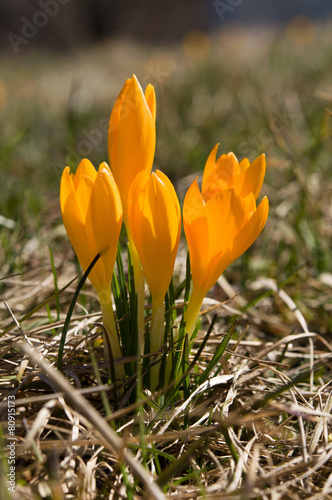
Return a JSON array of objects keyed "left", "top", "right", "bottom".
[{"left": 60, "top": 76, "right": 269, "bottom": 388}]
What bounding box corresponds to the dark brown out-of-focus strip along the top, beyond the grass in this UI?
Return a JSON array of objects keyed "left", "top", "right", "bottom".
[{"left": 0, "top": 0, "right": 332, "bottom": 50}]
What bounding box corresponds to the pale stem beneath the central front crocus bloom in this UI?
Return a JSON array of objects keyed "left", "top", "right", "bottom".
[{"left": 150, "top": 297, "right": 165, "bottom": 391}]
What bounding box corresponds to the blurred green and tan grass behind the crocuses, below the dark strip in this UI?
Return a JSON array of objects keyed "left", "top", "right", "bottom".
[{"left": 0, "top": 21, "right": 332, "bottom": 302}]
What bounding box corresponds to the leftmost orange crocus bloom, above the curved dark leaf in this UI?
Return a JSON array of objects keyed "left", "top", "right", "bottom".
[{"left": 60, "top": 159, "right": 122, "bottom": 292}]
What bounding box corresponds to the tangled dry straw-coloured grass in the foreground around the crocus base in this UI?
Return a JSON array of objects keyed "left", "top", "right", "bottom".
[{"left": 0, "top": 268, "right": 332, "bottom": 499}]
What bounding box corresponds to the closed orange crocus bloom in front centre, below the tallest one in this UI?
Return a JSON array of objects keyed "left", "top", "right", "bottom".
[{"left": 128, "top": 170, "right": 181, "bottom": 305}]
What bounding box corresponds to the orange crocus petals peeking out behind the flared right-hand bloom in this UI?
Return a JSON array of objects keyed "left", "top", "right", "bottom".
[{"left": 202, "top": 144, "right": 266, "bottom": 200}]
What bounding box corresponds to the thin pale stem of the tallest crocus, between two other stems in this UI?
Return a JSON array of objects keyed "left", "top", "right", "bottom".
[{"left": 126, "top": 224, "right": 145, "bottom": 355}]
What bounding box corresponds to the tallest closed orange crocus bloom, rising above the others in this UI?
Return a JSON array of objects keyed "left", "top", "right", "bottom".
[{"left": 108, "top": 75, "right": 156, "bottom": 225}]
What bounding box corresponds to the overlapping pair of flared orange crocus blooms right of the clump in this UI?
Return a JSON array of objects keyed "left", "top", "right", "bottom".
[{"left": 183, "top": 146, "right": 269, "bottom": 332}]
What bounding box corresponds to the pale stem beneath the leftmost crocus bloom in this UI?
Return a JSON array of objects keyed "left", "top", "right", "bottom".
[{"left": 98, "top": 289, "right": 125, "bottom": 380}]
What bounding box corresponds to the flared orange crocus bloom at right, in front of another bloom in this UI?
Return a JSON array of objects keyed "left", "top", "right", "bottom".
[{"left": 183, "top": 180, "right": 269, "bottom": 333}]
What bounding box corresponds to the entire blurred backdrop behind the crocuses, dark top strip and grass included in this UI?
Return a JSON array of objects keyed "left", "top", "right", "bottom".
[{"left": 0, "top": 0, "right": 332, "bottom": 328}]
